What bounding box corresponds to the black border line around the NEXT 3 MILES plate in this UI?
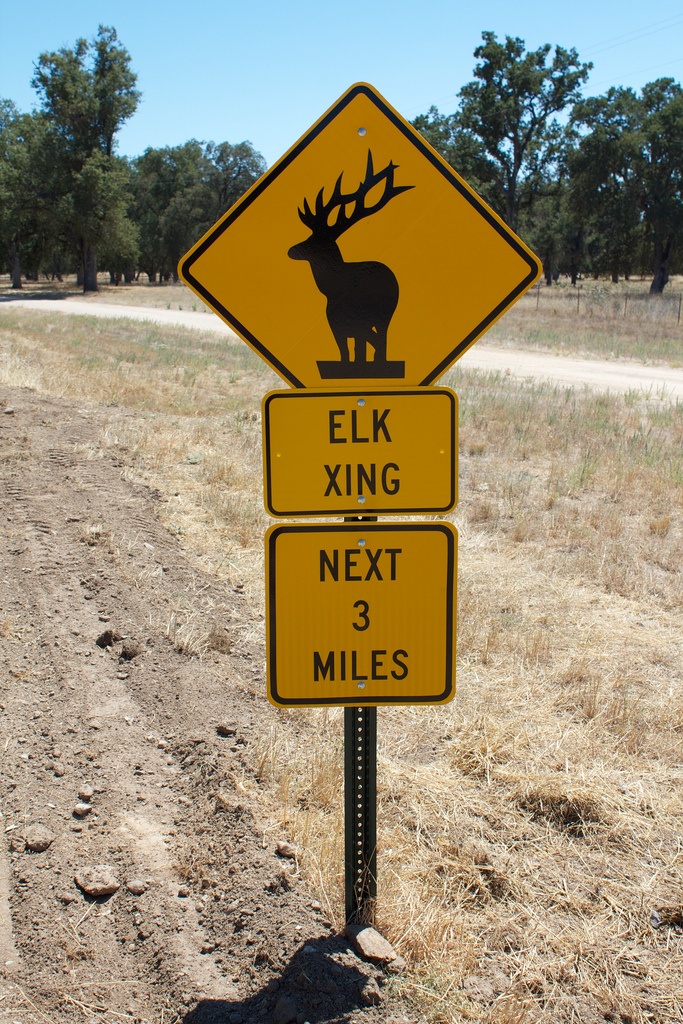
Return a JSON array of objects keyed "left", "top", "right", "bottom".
[{"left": 266, "top": 522, "right": 458, "bottom": 708}]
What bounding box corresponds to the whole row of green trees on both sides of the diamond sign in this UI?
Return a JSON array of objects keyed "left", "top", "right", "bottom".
[{"left": 0, "top": 26, "right": 683, "bottom": 294}]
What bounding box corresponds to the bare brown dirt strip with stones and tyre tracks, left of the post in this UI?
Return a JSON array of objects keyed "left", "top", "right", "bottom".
[{"left": 0, "top": 388, "right": 412, "bottom": 1024}]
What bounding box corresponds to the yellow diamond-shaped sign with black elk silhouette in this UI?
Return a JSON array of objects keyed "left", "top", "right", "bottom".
[{"left": 179, "top": 84, "right": 541, "bottom": 388}]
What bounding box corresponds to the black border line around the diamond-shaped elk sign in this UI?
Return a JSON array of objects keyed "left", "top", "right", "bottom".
[{"left": 180, "top": 83, "right": 539, "bottom": 388}]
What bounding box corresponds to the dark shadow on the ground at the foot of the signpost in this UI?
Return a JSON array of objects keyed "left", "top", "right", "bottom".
[{"left": 182, "top": 935, "right": 387, "bottom": 1024}]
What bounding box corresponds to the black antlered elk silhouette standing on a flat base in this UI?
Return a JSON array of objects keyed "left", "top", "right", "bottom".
[{"left": 288, "top": 151, "right": 415, "bottom": 379}]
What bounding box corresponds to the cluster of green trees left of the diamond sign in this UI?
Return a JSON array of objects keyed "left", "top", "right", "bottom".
[{"left": 0, "top": 26, "right": 265, "bottom": 291}]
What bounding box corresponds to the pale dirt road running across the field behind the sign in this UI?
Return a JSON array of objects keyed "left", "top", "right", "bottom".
[{"left": 5, "top": 298, "right": 683, "bottom": 399}]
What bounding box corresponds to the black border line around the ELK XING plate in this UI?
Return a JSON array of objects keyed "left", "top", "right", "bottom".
[{"left": 262, "top": 387, "right": 458, "bottom": 519}]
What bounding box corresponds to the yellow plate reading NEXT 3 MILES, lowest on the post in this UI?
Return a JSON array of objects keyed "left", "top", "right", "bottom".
[{"left": 265, "top": 522, "right": 458, "bottom": 708}]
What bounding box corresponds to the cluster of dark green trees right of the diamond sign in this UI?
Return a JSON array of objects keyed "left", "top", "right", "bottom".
[{"left": 413, "top": 32, "right": 683, "bottom": 293}]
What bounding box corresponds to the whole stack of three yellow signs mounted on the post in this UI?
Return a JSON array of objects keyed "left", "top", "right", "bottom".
[{"left": 180, "top": 84, "right": 541, "bottom": 707}]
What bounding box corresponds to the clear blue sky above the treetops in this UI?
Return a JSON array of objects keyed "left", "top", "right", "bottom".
[{"left": 0, "top": 0, "right": 683, "bottom": 164}]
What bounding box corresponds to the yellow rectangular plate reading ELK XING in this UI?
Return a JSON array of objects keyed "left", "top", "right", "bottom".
[{"left": 262, "top": 387, "right": 458, "bottom": 518}]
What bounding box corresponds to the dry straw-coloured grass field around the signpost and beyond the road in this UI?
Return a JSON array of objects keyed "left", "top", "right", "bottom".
[{"left": 0, "top": 283, "right": 683, "bottom": 1024}]
